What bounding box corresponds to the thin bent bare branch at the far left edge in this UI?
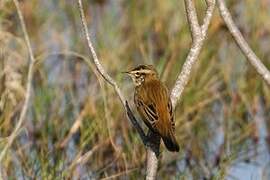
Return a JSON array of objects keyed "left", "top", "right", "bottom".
[{"left": 0, "top": 0, "right": 35, "bottom": 162}]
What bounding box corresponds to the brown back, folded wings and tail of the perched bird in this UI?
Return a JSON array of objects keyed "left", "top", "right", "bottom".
[{"left": 135, "top": 83, "right": 179, "bottom": 151}]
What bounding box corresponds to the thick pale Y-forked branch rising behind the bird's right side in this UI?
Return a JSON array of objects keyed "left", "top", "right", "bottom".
[{"left": 171, "top": 0, "right": 216, "bottom": 109}]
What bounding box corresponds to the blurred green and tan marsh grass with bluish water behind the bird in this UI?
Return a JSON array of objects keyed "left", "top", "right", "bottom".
[{"left": 0, "top": 0, "right": 270, "bottom": 179}]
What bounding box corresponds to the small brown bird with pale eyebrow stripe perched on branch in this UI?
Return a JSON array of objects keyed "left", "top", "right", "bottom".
[{"left": 126, "top": 65, "right": 179, "bottom": 151}]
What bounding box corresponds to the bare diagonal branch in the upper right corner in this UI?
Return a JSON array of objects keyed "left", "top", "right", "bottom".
[{"left": 217, "top": 0, "right": 270, "bottom": 86}]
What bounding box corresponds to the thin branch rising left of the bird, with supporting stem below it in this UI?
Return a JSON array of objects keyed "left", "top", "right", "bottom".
[{"left": 78, "top": 0, "right": 160, "bottom": 179}]
